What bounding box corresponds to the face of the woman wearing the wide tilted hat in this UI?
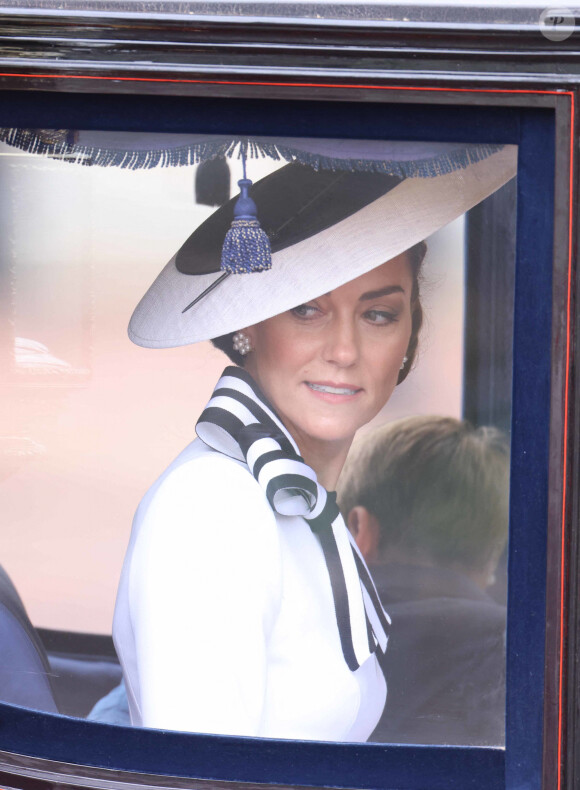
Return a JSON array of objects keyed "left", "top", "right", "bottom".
[{"left": 245, "top": 253, "right": 413, "bottom": 450}]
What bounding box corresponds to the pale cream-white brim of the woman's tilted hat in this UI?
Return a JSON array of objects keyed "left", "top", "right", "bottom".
[{"left": 129, "top": 145, "right": 517, "bottom": 348}]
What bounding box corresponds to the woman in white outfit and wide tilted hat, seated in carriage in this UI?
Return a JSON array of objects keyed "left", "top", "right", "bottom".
[{"left": 114, "top": 145, "right": 515, "bottom": 741}]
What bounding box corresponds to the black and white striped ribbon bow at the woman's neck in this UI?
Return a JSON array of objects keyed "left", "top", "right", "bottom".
[{"left": 196, "top": 367, "right": 390, "bottom": 672}]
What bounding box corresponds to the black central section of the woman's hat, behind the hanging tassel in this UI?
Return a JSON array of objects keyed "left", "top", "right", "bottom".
[{"left": 175, "top": 163, "right": 402, "bottom": 274}]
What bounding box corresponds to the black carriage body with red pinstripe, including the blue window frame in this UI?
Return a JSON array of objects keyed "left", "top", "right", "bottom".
[{"left": 0, "top": 0, "right": 580, "bottom": 790}]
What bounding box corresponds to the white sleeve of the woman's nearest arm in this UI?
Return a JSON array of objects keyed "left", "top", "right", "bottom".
[{"left": 129, "top": 456, "right": 281, "bottom": 736}]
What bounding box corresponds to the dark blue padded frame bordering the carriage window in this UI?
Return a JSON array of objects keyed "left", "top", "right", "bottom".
[{"left": 0, "top": 90, "right": 555, "bottom": 790}]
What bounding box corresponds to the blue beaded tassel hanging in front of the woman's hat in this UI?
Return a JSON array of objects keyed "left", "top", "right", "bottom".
[{"left": 221, "top": 156, "right": 272, "bottom": 274}]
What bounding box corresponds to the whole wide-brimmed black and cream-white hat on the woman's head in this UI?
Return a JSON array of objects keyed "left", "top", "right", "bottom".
[{"left": 129, "top": 143, "right": 517, "bottom": 348}]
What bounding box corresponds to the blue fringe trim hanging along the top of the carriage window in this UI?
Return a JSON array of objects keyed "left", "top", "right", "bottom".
[{"left": 0, "top": 129, "right": 503, "bottom": 178}]
